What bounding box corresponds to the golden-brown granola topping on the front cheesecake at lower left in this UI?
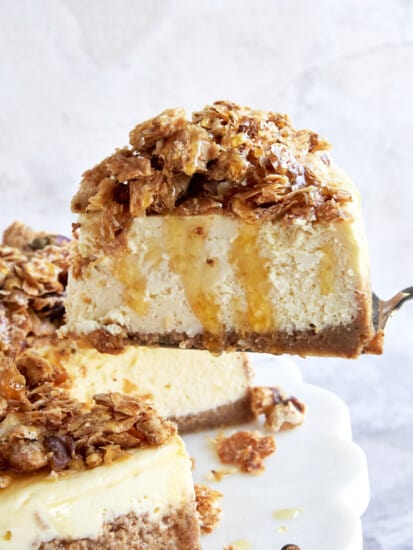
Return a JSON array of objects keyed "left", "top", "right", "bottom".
[{"left": 0, "top": 351, "right": 176, "bottom": 478}]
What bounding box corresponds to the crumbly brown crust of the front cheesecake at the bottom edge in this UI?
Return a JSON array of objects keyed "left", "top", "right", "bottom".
[{"left": 40, "top": 502, "right": 200, "bottom": 550}]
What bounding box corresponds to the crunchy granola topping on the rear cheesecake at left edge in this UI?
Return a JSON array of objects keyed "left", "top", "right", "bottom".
[{"left": 0, "top": 222, "right": 70, "bottom": 356}]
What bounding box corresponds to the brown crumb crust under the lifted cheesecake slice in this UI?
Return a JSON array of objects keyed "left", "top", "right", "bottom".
[{"left": 83, "top": 313, "right": 380, "bottom": 358}]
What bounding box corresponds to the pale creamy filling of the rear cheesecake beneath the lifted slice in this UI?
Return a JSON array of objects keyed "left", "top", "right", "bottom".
[{"left": 41, "top": 343, "right": 250, "bottom": 418}]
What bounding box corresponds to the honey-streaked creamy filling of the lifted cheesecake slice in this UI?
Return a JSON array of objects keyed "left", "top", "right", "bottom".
[{"left": 66, "top": 209, "right": 368, "bottom": 338}]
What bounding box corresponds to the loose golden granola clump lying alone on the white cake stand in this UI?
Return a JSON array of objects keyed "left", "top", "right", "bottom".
[{"left": 217, "top": 431, "right": 276, "bottom": 474}]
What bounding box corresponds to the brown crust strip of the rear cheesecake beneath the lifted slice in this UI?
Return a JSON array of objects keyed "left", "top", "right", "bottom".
[{"left": 170, "top": 391, "right": 254, "bottom": 434}]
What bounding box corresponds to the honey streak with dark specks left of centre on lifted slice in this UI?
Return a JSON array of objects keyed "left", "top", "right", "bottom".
[{"left": 165, "top": 216, "right": 221, "bottom": 336}]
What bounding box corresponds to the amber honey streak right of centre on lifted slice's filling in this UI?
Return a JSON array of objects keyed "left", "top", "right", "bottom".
[{"left": 229, "top": 223, "right": 274, "bottom": 333}]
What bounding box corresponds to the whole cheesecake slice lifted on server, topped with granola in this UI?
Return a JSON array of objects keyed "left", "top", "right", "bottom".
[{"left": 64, "top": 102, "right": 374, "bottom": 357}]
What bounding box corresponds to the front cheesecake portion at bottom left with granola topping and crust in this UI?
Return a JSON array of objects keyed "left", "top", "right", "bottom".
[{"left": 0, "top": 352, "right": 200, "bottom": 550}]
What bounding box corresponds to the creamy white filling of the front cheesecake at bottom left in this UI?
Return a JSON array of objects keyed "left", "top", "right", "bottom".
[{"left": 0, "top": 438, "right": 194, "bottom": 550}]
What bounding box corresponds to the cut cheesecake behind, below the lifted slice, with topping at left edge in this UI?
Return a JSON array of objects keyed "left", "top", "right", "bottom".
[{"left": 0, "top": 223, "right": 253, "bottom": 433}]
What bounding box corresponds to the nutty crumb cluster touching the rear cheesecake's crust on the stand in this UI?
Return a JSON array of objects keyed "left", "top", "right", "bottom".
[{"left": 251, "top": 386, "right": 305, "bottom": 432}]
